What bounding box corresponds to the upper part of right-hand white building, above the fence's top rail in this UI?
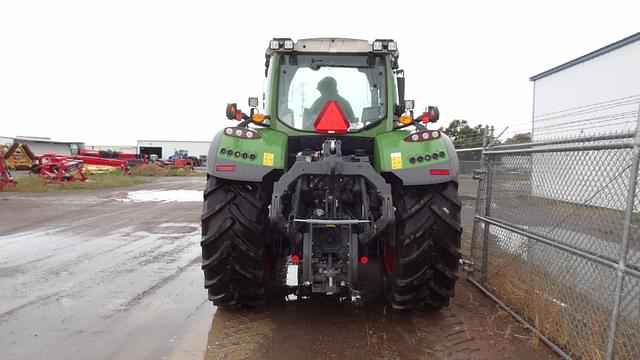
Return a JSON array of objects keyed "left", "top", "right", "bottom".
[{"left": 530, "top": 33, "right": 640, "bottom": 141}]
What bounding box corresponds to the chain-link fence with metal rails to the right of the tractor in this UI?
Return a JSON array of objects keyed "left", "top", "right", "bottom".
[{"left": 469, "top": 114, "right": 640, "bottom": 359}]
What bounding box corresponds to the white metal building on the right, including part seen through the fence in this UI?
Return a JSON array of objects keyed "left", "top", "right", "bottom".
[{"left": 531, "top": 33, "right": 640, "bottom": 210}]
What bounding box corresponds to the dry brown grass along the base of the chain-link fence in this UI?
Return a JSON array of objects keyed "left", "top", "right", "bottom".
[{"left": 489, "top": 254, "right": 640, "bottom": 359}]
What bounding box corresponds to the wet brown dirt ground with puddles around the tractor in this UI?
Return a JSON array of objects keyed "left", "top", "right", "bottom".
[{"left": 0, "top": 177, "right": 557, "bottom": 360}]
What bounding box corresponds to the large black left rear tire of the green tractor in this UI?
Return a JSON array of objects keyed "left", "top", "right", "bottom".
[{"left": 200, "top": 176, "right": 276, "bottom": 308}]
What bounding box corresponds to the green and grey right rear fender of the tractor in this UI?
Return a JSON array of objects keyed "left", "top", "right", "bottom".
[{"left": 374, "top": 131, "right": 460, "bottom": 186}]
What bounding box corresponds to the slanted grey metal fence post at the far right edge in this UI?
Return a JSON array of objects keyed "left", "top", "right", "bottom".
[{"left": 606, "top": 103, "right": 640, "bottom": 360}]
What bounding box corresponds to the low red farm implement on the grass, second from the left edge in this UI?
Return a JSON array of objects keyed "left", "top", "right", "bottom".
[{"left": 34, "top": 153, "right": 87, "bottom": 183}]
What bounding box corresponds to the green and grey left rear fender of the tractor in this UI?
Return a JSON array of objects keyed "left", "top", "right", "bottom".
[{"left": 207, "top": 127, "right": 287, "bottom": 182}]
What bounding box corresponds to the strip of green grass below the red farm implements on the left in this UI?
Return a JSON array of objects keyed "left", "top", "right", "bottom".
[{"left": 3, "top": 174, "right": 148, "bottom": 192}]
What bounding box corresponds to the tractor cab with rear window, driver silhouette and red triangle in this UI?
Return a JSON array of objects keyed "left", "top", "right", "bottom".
[{"left": 227, "top": 38, "right": 437, "bottom": 136}]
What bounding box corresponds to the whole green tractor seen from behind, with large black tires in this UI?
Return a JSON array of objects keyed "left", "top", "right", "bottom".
[{"left": 201, "top": 38, "right": 462, "bottom": 309}]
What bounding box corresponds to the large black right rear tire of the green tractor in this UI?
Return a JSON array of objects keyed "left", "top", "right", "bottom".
[{"left": 383, "top": 182, "right": 462, "bottom": 310}]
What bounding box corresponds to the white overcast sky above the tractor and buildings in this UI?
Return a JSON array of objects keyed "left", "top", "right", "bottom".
[{"left": 0, "top": 0, "right": 640, "bottom": 145}]
